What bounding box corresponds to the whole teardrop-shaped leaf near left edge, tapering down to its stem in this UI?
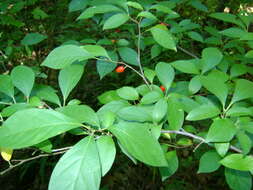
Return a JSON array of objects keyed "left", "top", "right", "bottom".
[{"left": 11, "top": 66, "right": 35, "bottom": 97}]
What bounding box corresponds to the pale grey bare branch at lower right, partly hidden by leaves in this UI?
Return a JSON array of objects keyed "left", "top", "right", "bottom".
[{"left": 161, "top": 130, "right": 242, "bottom": 153}]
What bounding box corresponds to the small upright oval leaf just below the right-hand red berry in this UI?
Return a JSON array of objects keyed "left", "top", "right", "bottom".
[{"left": 152, "top": 99, "right": 168, "bottom": 123}]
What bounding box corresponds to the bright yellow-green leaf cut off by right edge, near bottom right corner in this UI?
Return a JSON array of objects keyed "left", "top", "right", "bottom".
[{"left": 220, "top": 154, "right": 253, "bottom": 171}]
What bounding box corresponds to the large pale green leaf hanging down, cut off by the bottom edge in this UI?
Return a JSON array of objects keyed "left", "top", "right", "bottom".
[{"left": 48, "top": 136, "right": 101, "bottom": 190}]
